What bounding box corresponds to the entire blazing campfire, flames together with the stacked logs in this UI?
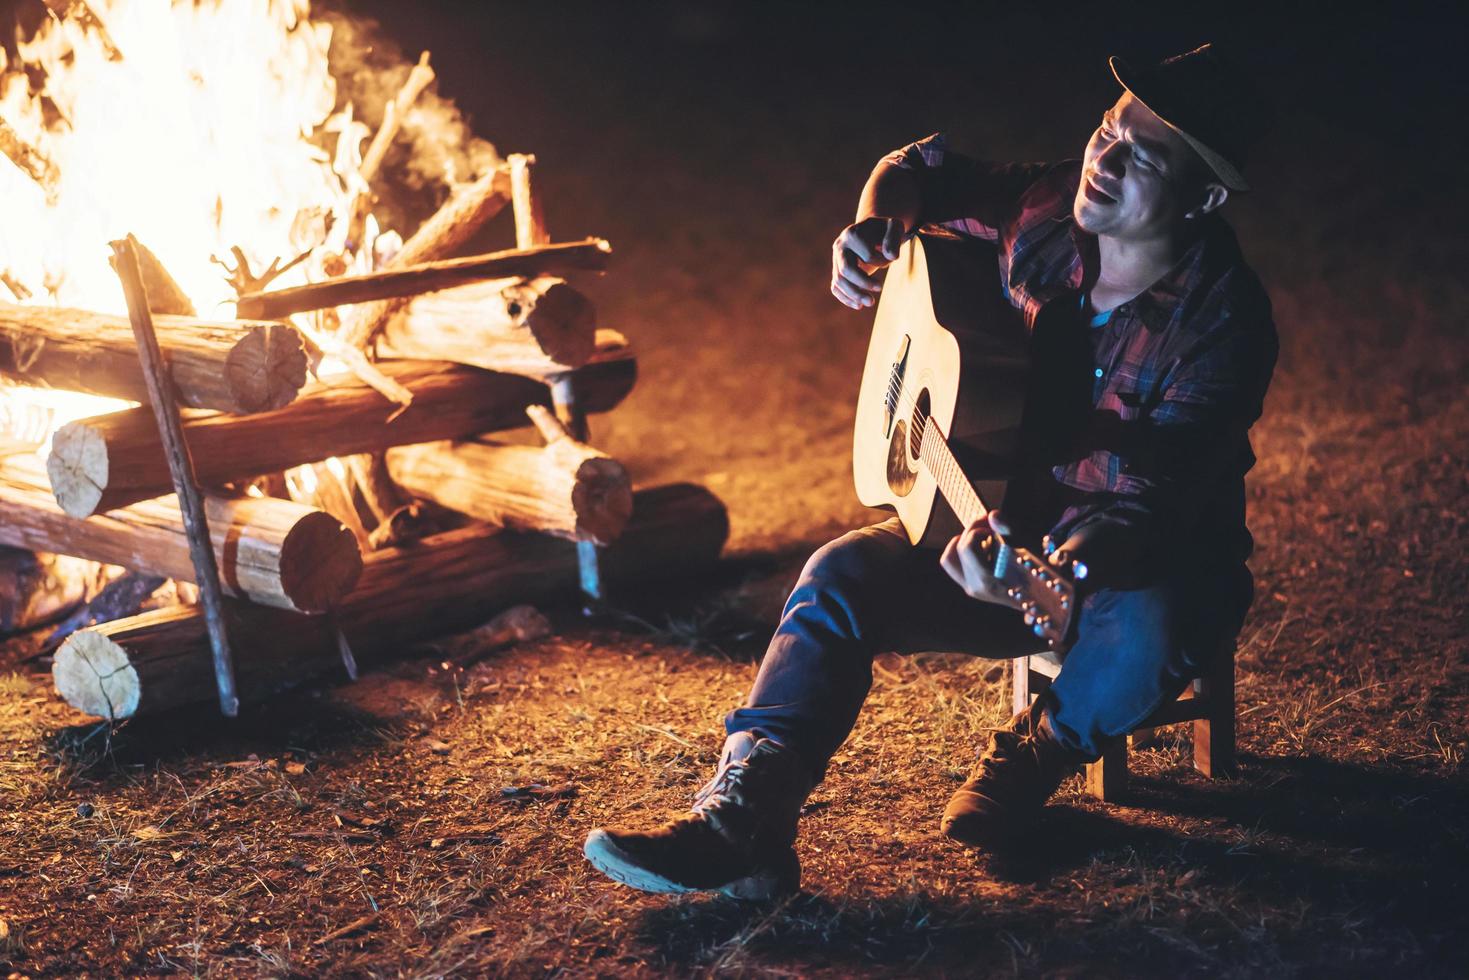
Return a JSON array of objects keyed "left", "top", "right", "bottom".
[{"left": 0, "top": 0, "right": 727, "bottom": 718}]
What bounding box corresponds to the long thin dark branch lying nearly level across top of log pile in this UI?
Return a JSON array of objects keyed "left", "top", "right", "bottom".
[{"left": 237, "top": 238, "right": 613, "bottom": 320}]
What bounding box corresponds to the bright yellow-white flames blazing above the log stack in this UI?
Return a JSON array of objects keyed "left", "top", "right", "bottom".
[{"left": 0, "top": 0, "right": 494, "bottom": 449}]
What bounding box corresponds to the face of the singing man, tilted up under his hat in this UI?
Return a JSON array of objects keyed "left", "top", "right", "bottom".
[{"left": 1071, "top": 91, "right": 1202, "bottom": 241}]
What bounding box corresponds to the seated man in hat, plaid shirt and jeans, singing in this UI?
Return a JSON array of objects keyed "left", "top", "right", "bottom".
[{"left": 585, "top": 46, "right": 1277, "bottom": 898}]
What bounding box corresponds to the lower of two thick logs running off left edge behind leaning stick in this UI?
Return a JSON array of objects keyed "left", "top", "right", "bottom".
[{"left": 0, "top": 457, "right": 361, "bottom": 613}]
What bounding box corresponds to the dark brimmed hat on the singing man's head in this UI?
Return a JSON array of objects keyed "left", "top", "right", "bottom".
[{"left": 1108, "top": 44, "right": 1269, "bottom": 191}]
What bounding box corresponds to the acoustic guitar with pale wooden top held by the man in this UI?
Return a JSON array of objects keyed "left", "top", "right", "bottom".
[{"left": 852, "top": 235, "right": 1086, "bottom": 648}]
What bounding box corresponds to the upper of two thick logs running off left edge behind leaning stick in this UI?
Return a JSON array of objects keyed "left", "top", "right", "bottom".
[{"left": 0, "top": 303, "right": 306, "bottom": 413}]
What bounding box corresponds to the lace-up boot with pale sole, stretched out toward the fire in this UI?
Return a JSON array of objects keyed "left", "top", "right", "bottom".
[{"left": 582, "top": 732, "right": 811, "bottom": 899}]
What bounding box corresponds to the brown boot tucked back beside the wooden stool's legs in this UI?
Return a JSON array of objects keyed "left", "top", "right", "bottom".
[{"left": 942, "top": 698, "right": 1086, "bottom": 848}]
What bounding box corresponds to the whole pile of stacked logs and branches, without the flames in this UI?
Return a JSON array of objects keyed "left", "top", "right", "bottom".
[{"left": 0, "top": 143, "right": 729, "bottom": 718}]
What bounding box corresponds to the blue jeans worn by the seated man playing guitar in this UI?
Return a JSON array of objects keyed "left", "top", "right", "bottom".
[{"left": 724, "top": 517, "right": 1252, "bottom": 780}]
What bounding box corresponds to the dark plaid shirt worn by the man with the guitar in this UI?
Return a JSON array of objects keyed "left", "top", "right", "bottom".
[{"left": 884, "top": 134, "right": 1277, "bottom": 580}]
